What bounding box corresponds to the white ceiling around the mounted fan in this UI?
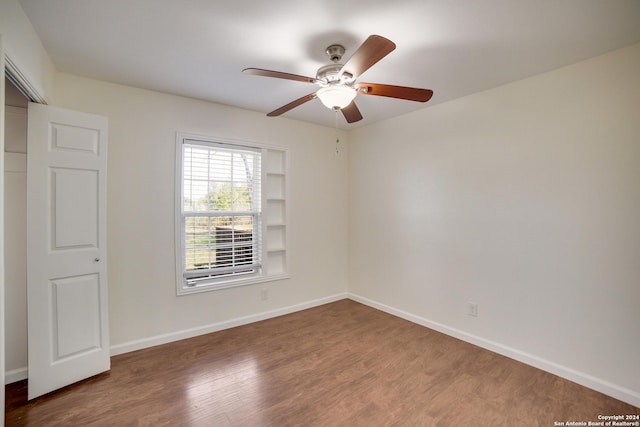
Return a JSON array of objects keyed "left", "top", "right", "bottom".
[{"left": 20, "top": 0, "right": 640, "bottom": 128}]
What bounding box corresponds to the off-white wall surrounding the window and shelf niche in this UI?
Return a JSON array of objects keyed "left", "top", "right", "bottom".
[{"left": 55, "top": 74, "right": 347, "bottom": 350}]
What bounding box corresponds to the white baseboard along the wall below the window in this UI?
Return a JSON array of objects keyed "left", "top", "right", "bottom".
[{"left": 111, "top": 292, "right": 348, "bottom": 356}]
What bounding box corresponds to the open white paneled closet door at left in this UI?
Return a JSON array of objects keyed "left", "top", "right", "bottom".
[{"left": 27, "top": 103, "right": 110, "bottom": 399}]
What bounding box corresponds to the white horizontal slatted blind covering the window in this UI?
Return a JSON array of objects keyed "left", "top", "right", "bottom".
[{"left": 181, "top": 139, "right": 262, "bottom": 287}]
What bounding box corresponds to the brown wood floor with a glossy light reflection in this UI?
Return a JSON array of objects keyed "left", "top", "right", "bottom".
[{"left": 6, "top": 300, "right": 640, "bottom": 427}]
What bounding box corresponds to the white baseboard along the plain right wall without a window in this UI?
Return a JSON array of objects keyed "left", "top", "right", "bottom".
[{"left": 348, "top": 293, "right": 640, "bottom": 407}]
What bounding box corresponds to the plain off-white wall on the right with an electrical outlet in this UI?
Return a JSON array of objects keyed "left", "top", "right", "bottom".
[{"left": 349, "top": 44, "right": 640, "bottom": 405}]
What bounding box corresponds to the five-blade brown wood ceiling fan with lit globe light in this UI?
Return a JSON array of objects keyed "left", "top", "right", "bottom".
[{"left": 242, "top": 35, "right": 433, "bottom": 123}]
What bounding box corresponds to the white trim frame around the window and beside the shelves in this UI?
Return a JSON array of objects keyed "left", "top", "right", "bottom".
[{"left": 175, "top": 132, "right": 289, "bottom": 295}]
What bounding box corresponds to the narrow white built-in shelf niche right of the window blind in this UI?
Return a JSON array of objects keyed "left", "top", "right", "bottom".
[{"left": 264, "top": 148, "right": 288, "bottom": 275}]
